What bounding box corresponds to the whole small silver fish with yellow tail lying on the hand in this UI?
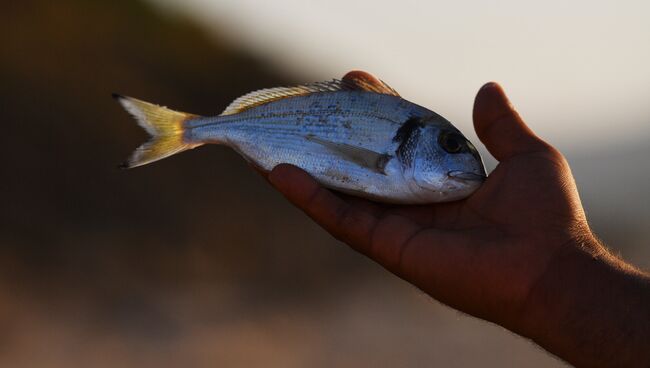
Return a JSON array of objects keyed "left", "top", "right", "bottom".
[{"left": 114, "top": 71, "right": 487, "bottom": 204}]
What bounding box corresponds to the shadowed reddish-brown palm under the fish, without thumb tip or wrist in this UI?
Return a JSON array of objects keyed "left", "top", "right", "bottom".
[{"left": 333, "top": 152, "right": 579, "bottom": 317}]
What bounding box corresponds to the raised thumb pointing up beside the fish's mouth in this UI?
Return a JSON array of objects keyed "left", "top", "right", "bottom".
[{"left": 473, "top": 82, "right": 549, "bottom": 161}]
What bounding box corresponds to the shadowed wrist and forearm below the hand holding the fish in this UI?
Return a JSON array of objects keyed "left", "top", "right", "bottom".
[{"left": 517, "top": 239, "right": 650, "bottom": 367}]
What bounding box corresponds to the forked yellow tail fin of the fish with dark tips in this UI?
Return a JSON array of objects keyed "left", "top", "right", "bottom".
[{"left": 113, "top": 94, "right": 202, "bottom": 169}]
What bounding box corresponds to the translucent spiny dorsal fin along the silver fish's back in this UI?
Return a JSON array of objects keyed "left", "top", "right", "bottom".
[{"left": 221, "top": 71, "right": 399, "bottom": 115}]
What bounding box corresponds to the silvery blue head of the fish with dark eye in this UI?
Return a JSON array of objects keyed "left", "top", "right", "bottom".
[{"left": 402, "top": 117, "right": 487, "bottom": 202}]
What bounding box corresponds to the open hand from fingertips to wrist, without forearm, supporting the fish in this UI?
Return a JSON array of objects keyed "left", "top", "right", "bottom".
[{"left": 268, "top": 83, "right": 648, "bottom": 362}]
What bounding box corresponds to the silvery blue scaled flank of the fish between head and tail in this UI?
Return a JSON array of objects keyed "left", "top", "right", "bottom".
[{"left": 190, "top": 91, "right": 426, "bottom": 201}]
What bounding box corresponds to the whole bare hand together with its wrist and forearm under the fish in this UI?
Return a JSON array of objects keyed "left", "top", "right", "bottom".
[{"left": 268, "top": 83, "right": 650, "bottom": 367}]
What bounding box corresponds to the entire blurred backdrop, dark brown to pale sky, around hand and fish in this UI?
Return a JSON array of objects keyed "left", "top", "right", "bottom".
[{"left": 0, "top": 0, "right": 650, "bottom": 367}]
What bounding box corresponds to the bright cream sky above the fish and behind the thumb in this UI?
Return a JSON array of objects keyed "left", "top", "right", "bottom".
[{"left": 149, "top": 0, "right": 650, "bottom": 150}]
